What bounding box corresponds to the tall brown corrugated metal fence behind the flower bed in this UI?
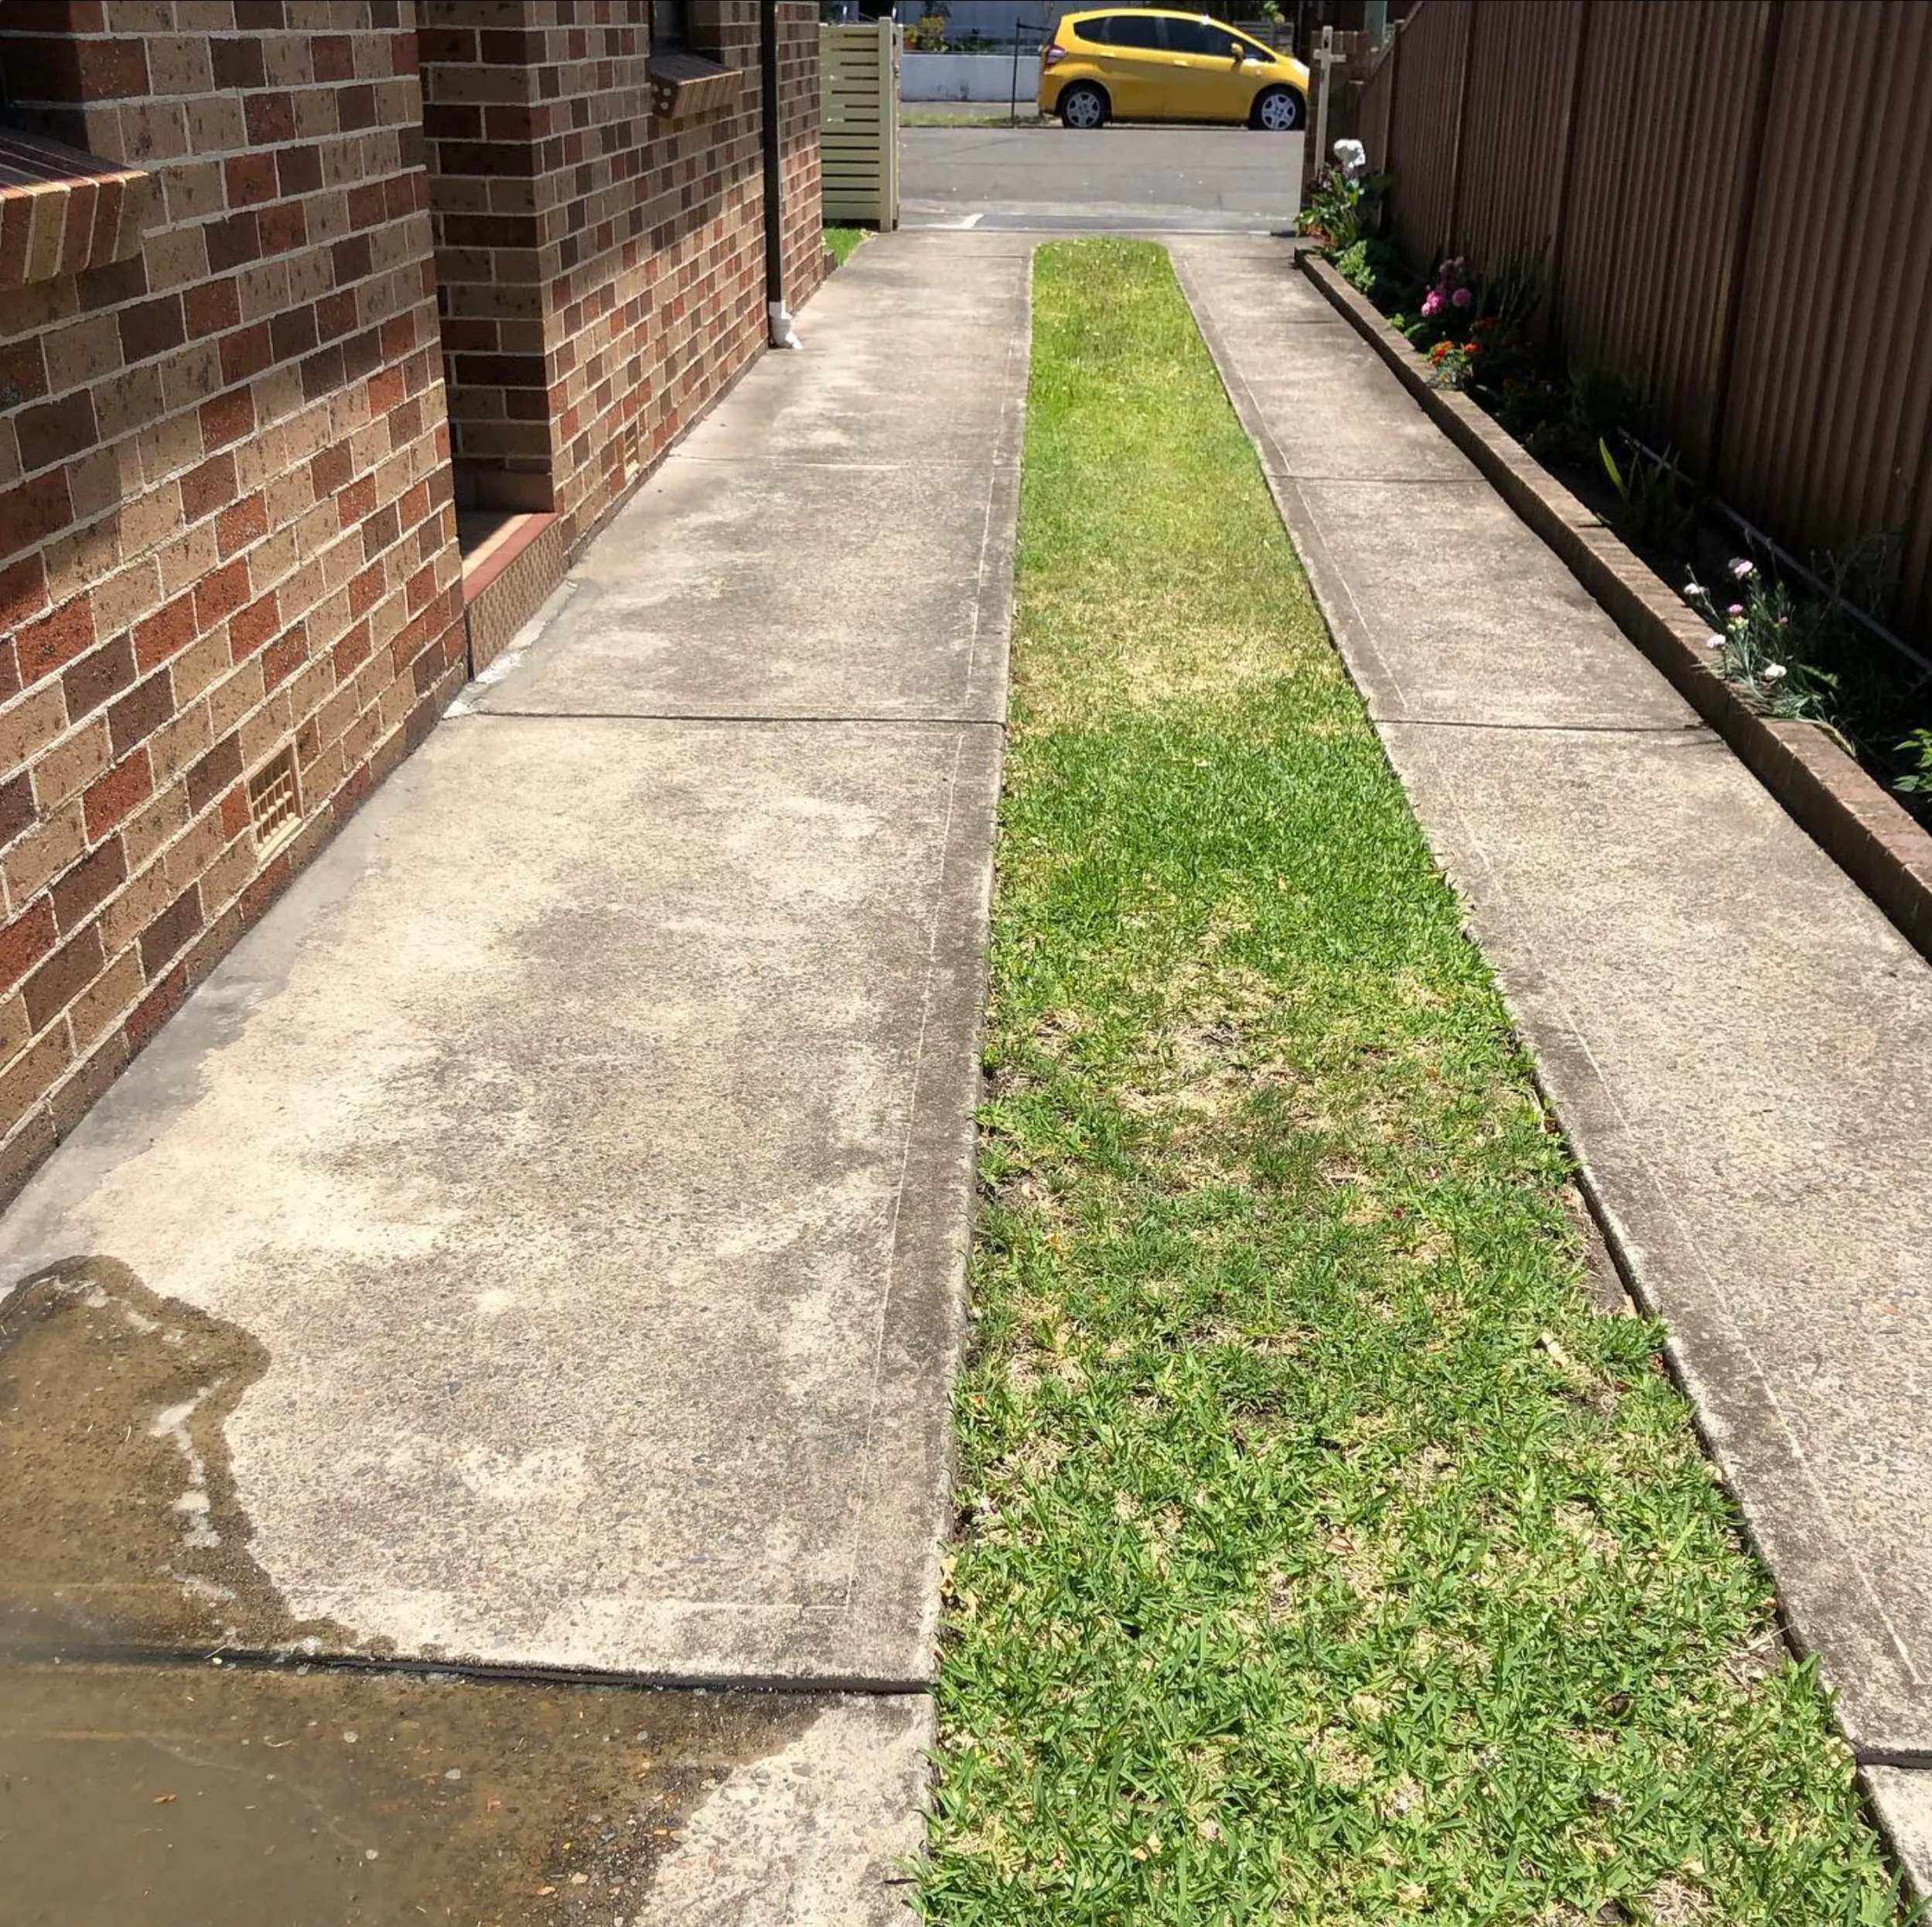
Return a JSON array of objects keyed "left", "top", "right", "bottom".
[{"left": 1360, "top": 0, "right": 1932, "bottom": 642}]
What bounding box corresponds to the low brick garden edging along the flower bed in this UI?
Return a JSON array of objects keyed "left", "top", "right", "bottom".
[{"left": 1300, "top": 251, "right": 1932, "bottom": 958}]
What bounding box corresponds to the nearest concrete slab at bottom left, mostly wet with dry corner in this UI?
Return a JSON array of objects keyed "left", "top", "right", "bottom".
[{"left": 0, "top": 1662, "right": 931, "bottom": 1927}]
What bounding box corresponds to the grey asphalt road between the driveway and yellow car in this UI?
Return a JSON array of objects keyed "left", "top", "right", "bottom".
[{"left": 900, "top": 124, "right": 1302, "bottom": 234}]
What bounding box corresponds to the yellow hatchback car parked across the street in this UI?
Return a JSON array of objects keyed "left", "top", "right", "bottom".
[{"left": 1039, "top": 8, "right": 1308, "bottom": 133}]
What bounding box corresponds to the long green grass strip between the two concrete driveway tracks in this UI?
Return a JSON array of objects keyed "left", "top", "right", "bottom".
[{"left": 920, "top": 240, "right": 1901, "bottom": 1927}]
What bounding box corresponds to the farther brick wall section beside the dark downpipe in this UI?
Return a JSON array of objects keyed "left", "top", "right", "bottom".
[{"left": 423, "top": 0, "right": 823, "bottom": 549}]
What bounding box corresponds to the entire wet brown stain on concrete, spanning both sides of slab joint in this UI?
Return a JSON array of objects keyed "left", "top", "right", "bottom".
[{"left": 0, "top": 1259, "right": 825, "bottom": 1927}]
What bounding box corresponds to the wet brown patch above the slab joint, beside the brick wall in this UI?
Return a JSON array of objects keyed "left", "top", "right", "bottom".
[{"left": 0, "top": 1259, "right": 353, "bottom": 1655}]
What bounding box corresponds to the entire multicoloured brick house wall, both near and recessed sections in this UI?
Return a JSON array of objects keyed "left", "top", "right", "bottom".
[{"left": 0, "top": 0, "right": 823, "bottom": 1198}]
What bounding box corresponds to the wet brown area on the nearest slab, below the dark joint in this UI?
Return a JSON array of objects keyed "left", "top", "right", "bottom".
[{"left": 0, "top": 1660, "right": 819, "bottom": 1927}]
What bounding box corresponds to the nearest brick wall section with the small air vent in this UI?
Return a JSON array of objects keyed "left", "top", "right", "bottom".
[{"left": 0, "top": 0, "right": 462, "bottom": 1193}]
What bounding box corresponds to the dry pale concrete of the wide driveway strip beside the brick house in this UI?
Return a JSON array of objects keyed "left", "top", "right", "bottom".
[{"left": 0, "top": 236, "right": 1028, "bottom": 1922}]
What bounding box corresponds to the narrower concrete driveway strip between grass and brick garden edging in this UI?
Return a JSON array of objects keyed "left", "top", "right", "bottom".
[{"left": 1175, "top": 241, "right": 1932, "bottom": 1865}]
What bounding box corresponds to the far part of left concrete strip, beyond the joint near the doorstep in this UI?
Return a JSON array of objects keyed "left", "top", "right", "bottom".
[{"left": 468, "top": 237, "right": 1028, "bottom": 723}]
